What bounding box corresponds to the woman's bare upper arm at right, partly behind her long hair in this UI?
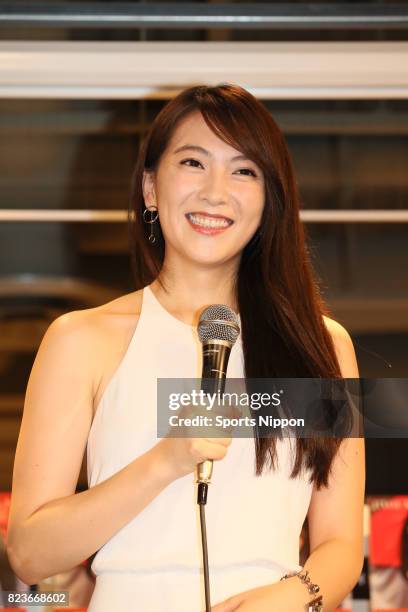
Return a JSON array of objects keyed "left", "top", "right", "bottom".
[{"left": 308, "top": 319, "right": 365, "bottom": 554}]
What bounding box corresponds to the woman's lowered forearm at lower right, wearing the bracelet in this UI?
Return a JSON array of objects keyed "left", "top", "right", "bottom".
[{"left": 283, "top": 540, "right": 363, "bottom": 612}]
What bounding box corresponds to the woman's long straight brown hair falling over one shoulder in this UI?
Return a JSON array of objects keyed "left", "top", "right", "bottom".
[{"left": 128, "top": 83, "right": 342, "bottom": 488}]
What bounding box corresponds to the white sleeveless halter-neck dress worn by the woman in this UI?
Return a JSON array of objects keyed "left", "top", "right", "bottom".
[{"left": 87, "top": 286, "right": 312, "bottom": 612}]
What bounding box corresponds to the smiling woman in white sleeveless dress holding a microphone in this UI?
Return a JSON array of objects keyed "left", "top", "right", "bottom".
[{"left": 8, "top": 84, "right": 365, "bottom": 612}]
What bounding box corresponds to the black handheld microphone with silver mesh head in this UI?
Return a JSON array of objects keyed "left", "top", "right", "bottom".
[{"left": 196, "top": 304, "right": 240, "bottom": 490}]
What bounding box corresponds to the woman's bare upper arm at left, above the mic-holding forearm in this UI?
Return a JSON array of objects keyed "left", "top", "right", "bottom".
[{"left": 8, "top": 311, "right": 98, "bottom": 545}]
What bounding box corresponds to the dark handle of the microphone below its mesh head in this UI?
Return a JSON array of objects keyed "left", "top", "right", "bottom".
[{"left": 197, "top": 340, "right": 231, "bottom": 483}]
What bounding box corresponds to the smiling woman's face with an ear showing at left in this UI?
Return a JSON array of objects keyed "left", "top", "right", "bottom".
[{"left": 143, "top": 112, "right": 264, "bottom": 264}]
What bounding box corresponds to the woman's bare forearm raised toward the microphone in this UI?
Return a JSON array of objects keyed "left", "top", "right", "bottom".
[{"left": 8, "top": 445, "right": 172, "bottom": 584}]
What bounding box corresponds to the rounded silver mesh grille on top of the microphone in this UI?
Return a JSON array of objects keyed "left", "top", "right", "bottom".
[{"left": 197, "top": 304, "right": 240, "bottom": 345}]
